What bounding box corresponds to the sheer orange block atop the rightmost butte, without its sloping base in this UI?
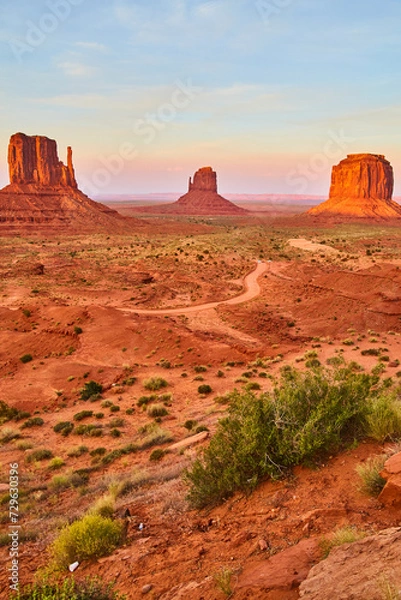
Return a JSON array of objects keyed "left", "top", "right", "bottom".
[{"left": 330, "top": 154, "right": 394, "bottom": 200}]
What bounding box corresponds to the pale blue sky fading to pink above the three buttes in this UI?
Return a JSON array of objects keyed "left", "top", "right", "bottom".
[{"left": 0, "top": 0, "right": 401, "bottom": 197}]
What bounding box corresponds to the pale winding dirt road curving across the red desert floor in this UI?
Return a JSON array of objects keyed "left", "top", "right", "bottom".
[{"left": 123, "top": 262, "right": 269, "bottom": 315}]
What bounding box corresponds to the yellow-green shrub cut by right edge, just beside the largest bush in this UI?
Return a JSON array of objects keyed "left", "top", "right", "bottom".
[{"left": 366, "top": 390, "right": 401, "bottom": 442}]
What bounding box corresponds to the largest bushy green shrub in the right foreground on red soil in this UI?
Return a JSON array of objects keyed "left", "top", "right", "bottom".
[{"left": 185, "top": 367, "right": 377, "bottom": 507}]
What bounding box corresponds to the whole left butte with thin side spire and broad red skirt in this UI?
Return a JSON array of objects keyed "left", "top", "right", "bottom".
[{"left": 0, "top": 133, "right": 135, "bottom": 231}]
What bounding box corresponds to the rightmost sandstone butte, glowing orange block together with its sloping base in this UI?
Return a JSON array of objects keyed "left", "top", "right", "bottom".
[{"left": 306, "top": 154, "right": 401, "bottom": 220}]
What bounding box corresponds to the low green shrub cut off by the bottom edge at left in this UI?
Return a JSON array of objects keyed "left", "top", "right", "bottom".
[{"left": 10, "top": 577, "right": 126, "bottom": 600}]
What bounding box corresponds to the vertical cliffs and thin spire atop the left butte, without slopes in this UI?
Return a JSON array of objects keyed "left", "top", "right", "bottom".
[{"left": 8, "top": 133, "right": 78, "bottom": 189}]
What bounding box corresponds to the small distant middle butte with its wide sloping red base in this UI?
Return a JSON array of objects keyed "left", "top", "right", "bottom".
[{"left": 134, "top": 167, "right": 248, "bottom": 216}]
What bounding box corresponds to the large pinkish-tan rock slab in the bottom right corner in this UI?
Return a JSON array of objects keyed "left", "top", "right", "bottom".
[{"left": 299, "top": 528, "right": 401, "bottom": 600}]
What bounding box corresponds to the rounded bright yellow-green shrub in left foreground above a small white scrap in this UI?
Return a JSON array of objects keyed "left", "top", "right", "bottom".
[{"left": 52, "top": 514, "right": 123, "bottom": 568}]
